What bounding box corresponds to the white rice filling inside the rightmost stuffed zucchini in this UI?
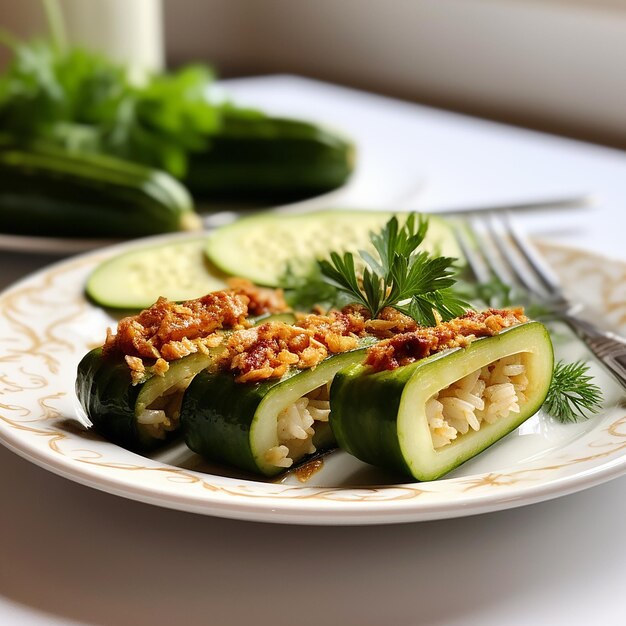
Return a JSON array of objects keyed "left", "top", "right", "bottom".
[{"left": 425, "top": 353, "right": 528, "bottom": 450}]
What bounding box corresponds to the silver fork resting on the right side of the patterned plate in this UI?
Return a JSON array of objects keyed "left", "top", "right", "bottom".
[{"left": 455, "top": 213, "right": 626, "bottom": 388}]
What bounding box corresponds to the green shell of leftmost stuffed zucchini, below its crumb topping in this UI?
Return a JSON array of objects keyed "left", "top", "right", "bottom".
[{"left": 76, "top": 348, "right": 217, "bottom": 451}]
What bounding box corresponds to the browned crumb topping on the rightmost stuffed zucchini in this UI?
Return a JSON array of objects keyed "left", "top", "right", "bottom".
[{"left": 365, "top": 308, "right": 528, "bottom": 371}]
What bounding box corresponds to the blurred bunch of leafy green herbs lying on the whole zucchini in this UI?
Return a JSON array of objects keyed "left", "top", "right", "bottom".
[{"left": 0, "top": 12, "right": 223, "bottom": 177}]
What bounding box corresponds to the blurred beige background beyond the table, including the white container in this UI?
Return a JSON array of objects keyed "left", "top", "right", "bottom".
[{"left": 0, "top": 0, "right": 626, "bottom": 148}]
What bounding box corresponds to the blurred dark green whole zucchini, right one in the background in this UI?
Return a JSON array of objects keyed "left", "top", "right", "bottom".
[{"left": 184, "top": 109, "right": 355, "bottom": 204}]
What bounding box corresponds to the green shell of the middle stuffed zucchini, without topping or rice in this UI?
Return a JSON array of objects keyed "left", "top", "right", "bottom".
[{"left": 180, "top": 349, "right": 364, "bottom": 476}]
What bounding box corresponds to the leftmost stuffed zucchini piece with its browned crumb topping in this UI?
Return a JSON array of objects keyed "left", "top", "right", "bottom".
[{"left": 76, "top": 281, "right": 295, "bottom": 451}]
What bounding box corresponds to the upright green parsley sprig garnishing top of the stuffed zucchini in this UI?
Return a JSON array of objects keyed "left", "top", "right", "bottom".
[{"left": 319, "top": 213, "right": 469, "bottom": 326}]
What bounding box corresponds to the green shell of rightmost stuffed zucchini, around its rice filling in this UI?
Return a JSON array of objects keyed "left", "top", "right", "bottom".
[{"left": 330, "top": 322, "right": 553, "bottom": 481}]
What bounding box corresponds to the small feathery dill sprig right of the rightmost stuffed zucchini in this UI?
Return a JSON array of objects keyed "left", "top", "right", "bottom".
[{"left": 544, "top": 361, "right": 602, "bottom": 423}]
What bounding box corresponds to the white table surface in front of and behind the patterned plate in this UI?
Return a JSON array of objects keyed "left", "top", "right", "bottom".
[{"left": 0, "top": 77, "right": 626, "bottom": 626}]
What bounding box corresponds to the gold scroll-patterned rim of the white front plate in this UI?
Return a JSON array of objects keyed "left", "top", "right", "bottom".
[{"left": 0, "top": 236, "right": 626, "bottom": 508}]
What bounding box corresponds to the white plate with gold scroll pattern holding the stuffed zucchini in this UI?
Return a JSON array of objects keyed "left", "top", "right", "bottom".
[{"left": 0, "top": 229, "right": 626, "bottom": 524}]
